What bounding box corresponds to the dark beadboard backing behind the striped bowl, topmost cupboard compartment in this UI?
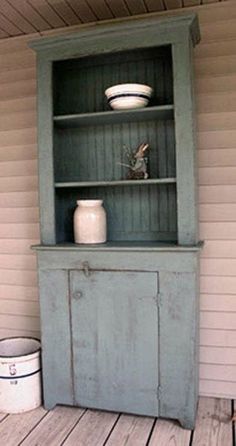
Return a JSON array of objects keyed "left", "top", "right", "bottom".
[{"left": 54, "top": 46, "right": 173, "bottom": 115}]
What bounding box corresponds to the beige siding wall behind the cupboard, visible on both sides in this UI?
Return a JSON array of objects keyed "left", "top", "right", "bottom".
[{"left": 0, "top": 0, "right": 236, "bottom": 398}]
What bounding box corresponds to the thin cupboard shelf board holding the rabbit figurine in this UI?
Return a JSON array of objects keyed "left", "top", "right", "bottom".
[{"left": 55, "top": 177, "right": 176, "bottom": 188}]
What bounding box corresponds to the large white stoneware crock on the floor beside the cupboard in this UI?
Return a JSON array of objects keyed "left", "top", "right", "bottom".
[{"left": 0, "top": 337, "right": 41, "bottom": 413}]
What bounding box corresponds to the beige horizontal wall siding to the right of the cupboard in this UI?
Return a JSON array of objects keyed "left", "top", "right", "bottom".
[{"left": 195, "top": 1, "right": 236, "bottom": 398}]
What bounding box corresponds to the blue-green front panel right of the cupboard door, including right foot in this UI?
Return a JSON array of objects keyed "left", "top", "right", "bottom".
[{"left": 160, "top": 266, "right": 198, "bottom": 428}]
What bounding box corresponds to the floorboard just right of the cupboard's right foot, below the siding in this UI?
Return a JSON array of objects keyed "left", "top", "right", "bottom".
[{"left": 192, "top": 398, "right": 233, "bottom": 446}]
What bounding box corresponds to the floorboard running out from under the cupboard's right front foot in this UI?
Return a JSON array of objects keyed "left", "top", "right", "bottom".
[{"left": 149, "top": 420, "right": 192, "bottom": 446}]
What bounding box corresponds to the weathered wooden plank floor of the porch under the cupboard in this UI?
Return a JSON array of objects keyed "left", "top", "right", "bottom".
[{"left": 0, "top": 398, "right": 235, "bottom": 446}]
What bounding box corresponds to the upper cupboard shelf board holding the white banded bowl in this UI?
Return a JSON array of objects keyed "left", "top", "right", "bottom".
[{"left": 54, "top": 104, "right": 174, "bottom": 128}]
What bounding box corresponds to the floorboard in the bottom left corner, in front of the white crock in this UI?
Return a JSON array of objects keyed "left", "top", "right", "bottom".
[{"left": 0, "top": 407, "right": 47, "bottom": 446}]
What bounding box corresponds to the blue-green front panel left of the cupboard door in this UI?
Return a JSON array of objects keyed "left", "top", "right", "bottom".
[{"left": 39, "top": 270, "right": 73, "bottom": 408}]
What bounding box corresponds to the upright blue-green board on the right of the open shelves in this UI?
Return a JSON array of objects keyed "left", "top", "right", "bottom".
[{"left": 173, "top": 37, "right": 198, "bottom": 245}]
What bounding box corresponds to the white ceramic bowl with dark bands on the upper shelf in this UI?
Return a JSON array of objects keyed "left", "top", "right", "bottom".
[{"left": 105, "top": 84, "right": 152, "bottom": 110}]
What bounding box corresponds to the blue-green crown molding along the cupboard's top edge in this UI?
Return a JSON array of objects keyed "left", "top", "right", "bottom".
[{"left": 29, "top": 14, "right": 200, "bottom": 60}]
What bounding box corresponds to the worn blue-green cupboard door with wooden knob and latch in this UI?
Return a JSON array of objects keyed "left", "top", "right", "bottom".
[{"left": 70, "top": 271, "right": 158, "bottom": 415}]
